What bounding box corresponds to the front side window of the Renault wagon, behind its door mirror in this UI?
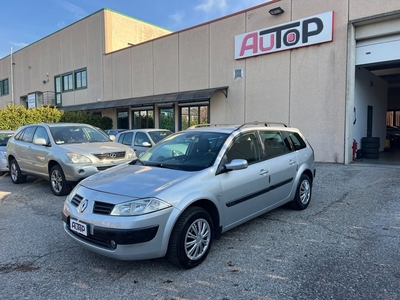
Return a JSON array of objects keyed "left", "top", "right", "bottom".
[{"left": 226, "top": 132, "right": 261, "bottom": 164}]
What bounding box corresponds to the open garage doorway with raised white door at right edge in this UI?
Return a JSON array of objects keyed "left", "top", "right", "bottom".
[{"left": 353, "top": 34, "right": 400, "bottom": 165}]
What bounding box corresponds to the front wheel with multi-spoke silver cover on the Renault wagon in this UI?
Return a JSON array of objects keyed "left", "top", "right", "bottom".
[{"left": 167, "top": 207, "right": 214, "bottom": 269}]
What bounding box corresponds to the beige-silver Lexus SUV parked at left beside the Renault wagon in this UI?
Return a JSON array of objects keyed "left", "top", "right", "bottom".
[{"left": 7, "top": 123, "right": 136, "bottom": 196}]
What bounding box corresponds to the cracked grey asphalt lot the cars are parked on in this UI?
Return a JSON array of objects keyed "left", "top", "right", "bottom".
[{"left": 0, "top": 163, "right": 400, "bottom": 300}]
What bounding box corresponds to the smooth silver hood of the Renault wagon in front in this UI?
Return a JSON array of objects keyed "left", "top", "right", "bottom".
[{"left": 80, "top": 164, "right": 193, "bottom": 198}]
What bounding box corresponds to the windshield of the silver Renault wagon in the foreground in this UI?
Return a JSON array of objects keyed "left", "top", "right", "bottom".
[{"left": 140, "top": 131, "right": 228, "bottom": 171}]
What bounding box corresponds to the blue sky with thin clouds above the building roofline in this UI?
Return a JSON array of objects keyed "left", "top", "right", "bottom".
[{"left": 0, "top": 0, "right": 268, "bottom": 59}]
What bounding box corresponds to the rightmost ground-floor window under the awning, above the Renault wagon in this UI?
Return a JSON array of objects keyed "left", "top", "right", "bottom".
[{"left": 179, "top": 104, "right": 210, "bottom": 130}]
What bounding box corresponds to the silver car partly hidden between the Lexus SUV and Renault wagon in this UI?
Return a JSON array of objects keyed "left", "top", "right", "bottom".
[{"left": 115, "top": 128, "right": 172, "bottom": 156}]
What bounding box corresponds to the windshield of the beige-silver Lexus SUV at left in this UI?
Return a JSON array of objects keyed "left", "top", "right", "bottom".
[{"left": 50, "top": 125, "right": 111, "bottom": 145}]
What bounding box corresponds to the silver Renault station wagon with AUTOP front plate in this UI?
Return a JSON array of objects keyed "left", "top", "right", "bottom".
[{"left": 62, "top": 122, "right": 315, "bottom": 268}]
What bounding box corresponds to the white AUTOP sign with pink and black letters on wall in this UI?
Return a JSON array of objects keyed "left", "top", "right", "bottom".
[{"left": 235, "top": 11, "right": 333, "bottom": 59}]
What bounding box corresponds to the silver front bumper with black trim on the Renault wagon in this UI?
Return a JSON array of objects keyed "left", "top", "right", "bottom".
[{"left": 62, "top": 195, "right": 174, "bottom": 260}]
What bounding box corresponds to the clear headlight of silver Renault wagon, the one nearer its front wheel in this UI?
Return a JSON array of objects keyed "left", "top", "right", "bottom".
[{"left": 111, "top": 198, "right": 171, "bottom": 216}]
